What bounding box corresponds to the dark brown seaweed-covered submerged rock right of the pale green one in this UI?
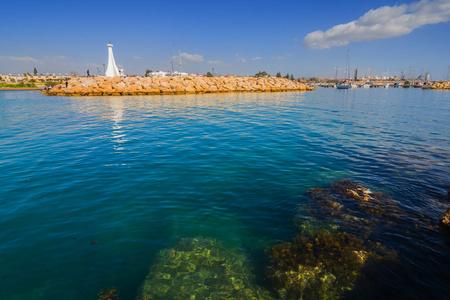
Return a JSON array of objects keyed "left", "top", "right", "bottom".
[{"left": 267, "top": 231, "right": 395, "bottom": 299}]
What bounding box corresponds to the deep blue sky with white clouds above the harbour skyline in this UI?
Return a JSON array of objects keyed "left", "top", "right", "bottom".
[{"left": 0, "top": 0, "right": 450, "bottom": 79}]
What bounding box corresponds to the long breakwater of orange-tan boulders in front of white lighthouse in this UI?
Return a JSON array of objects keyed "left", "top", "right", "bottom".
[{"left": 45, "top": 76, "right": 315, "bottom": 96}]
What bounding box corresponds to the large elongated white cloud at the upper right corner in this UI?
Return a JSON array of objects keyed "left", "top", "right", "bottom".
[{"left": 303, "top": 0, "right": 450, "bottom": 49}]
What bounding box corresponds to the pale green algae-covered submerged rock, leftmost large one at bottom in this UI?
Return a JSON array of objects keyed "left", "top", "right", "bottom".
[{"left": 139, "top": 238, "right": 274, "bottom": 300}]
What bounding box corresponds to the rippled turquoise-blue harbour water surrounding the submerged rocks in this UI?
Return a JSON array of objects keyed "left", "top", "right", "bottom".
[{"left": 0, "top": 89, "right": 450, "bottom": 300}]
